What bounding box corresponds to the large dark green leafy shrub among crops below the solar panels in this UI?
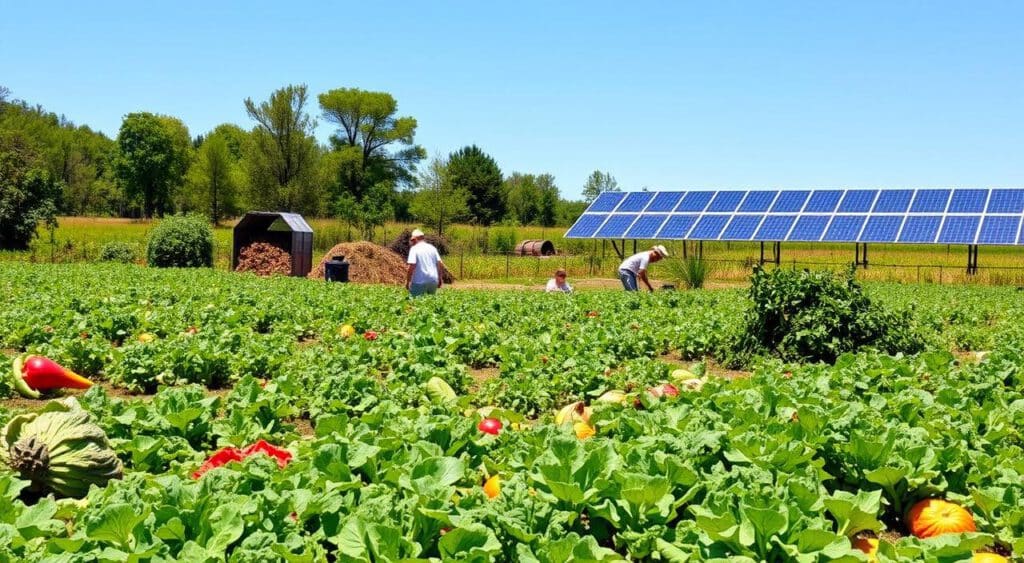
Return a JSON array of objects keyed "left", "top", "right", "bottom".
[{"left": 733, "top": 267, "right": 924, "bottom": 363}]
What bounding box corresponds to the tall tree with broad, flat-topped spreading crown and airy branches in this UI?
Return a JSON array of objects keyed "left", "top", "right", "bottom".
[{"left": 319, "top": 88, "right": 426, "bottom": 202}]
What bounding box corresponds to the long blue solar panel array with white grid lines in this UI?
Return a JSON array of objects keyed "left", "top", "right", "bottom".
[{"left": 565, "top": 188, "right": 1024, "bottom": 245}]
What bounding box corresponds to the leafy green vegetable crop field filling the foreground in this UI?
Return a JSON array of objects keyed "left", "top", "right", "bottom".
[{"left": 0, "top": 262, "right": 1024, "bottom": 563}]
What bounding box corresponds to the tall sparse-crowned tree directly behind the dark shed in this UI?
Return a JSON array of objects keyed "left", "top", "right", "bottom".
[{"left": 245, "top": 85, "right": 321, "bottom": 213}]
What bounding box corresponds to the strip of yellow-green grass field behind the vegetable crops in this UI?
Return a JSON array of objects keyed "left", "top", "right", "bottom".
[{"left": 0, "top": 217, "right": 1024, "bottom": 286}]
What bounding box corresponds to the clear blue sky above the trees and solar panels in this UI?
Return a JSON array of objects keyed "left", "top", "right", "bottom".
[{"left": 0, "top": 0, "right": 1024, "bottom": 197}]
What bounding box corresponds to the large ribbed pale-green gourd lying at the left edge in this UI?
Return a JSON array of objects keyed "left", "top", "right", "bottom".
[{"left": 0, "top": 397, "right": 124, "bottom": 499}]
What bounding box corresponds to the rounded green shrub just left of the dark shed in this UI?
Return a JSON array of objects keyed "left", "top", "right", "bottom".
[{"left": 146, "top": 215, "right": 213, "bottom": 268}]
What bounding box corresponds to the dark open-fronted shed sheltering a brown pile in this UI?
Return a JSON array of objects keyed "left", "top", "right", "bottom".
[{"left": 231, "top": 211, "right": 313, "bottom": 275}]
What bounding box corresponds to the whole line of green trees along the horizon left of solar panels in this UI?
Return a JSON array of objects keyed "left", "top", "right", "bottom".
[{"left": 0, "top": 85, "right": 617, "bottom": 248}]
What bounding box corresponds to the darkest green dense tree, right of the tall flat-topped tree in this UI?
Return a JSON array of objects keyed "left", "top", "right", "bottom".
[{"left": 446, "top": 144, "right": 505, "bottom": 225}]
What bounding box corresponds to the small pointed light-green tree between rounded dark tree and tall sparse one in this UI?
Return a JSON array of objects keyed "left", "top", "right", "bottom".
[{"left": 187, "top": 131, "right": 242, "bottom": 225}]
